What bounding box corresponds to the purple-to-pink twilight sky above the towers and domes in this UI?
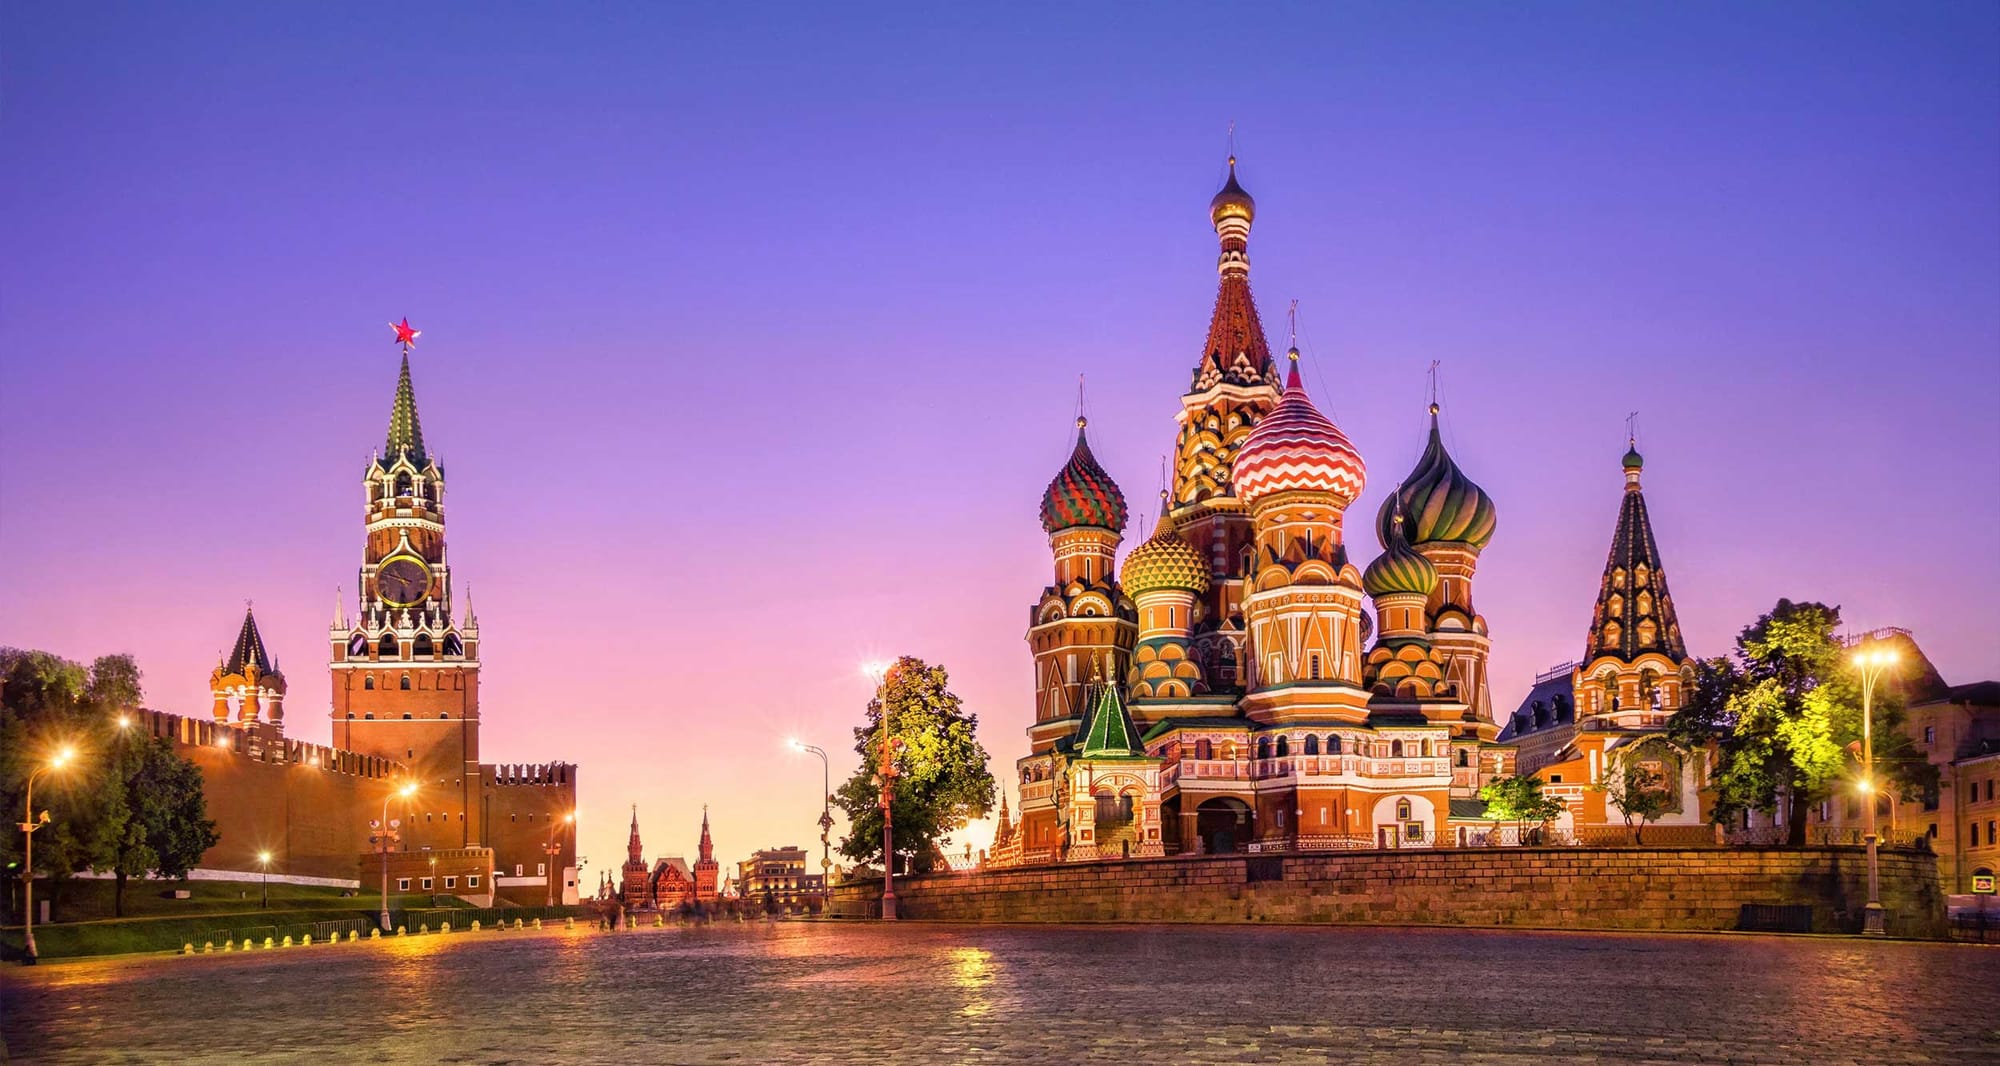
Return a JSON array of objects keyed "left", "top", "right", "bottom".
[{"left": 0, "top": 4, "right": 2000, "bottom": 880}]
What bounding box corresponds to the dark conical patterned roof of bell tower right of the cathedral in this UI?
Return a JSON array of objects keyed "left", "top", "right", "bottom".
[{"left": 1584, "top": 448, "right": 1688, "bottom": 662}]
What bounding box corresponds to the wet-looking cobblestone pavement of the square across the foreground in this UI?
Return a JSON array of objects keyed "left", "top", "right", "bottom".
[{"left": 0, "top": 922, "right": 2000, "bottom": 1066}]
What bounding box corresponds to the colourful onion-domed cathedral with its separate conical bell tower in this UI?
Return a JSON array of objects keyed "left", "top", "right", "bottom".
[{"left": 990, "top": 158, "right": 1706, "bottom": 864}]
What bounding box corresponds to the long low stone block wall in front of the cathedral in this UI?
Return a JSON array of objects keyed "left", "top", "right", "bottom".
[{"left": 834, "top": 846, "right": 1946, "bottom": 938}]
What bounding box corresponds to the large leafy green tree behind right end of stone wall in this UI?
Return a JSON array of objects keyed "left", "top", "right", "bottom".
[{"left": 1668, "top": 600, "right": 1936, "bottom": 846}]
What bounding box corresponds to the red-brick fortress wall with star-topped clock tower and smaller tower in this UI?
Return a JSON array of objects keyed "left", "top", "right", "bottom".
[{"left": 138, "top": 328, "right": 576, "bottom": 904}]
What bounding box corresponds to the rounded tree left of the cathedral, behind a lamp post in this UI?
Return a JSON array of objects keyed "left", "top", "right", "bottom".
[{"left": 834, "top": 656, "right": 994, "bottom": 872}]
